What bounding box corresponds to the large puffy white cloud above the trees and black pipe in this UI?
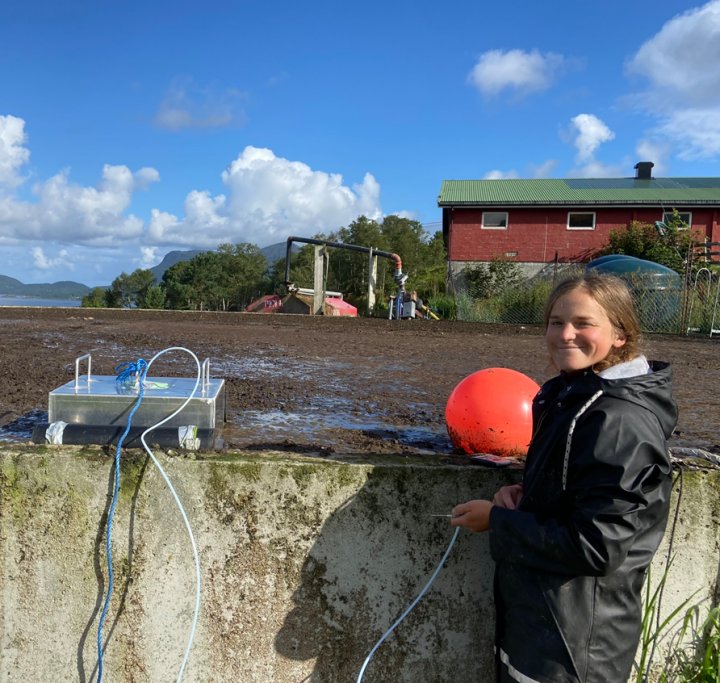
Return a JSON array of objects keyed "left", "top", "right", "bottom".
[{"left": 148, "top": 146, "right": 382, "bottom": 248}]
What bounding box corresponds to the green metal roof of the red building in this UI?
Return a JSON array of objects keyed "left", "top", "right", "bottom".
[{"left": 438, "top": 178, "right": 720, "bottom": 207}]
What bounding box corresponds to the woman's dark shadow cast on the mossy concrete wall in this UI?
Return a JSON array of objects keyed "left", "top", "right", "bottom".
[{"left": 275, "top": 467, "right": 494, "bottom": 683}]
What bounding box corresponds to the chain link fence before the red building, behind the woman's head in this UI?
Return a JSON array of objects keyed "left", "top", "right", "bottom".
[{"left": 450, "top": 264, "right": 720, "bottom": 338}]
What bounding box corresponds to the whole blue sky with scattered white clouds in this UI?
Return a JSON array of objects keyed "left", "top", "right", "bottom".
[{"left": 0, "top": 0, "right": 720, "bottom": 287}]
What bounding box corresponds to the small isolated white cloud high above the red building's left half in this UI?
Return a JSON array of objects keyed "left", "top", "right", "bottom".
[{"left": 468, "top": 50, "right": 566, "bottom": 96}]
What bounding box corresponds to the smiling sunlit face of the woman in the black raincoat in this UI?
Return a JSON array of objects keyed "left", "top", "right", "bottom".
[{"left": 545, "top": 289, "right": 625, "bottom": 372}]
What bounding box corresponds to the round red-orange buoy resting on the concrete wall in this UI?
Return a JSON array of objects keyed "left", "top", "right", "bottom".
[{"left": 445, "top": 368, "right": 540, "bottom": 456}]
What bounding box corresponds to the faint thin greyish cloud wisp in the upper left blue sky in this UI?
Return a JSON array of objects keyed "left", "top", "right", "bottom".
[{"left": 155, "top": 78, "right": 245, "bottom": 131}]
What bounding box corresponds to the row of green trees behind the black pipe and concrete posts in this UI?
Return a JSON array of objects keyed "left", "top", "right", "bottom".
[{"left": 95, "top": 227, "right": 447, "bottom": 318}]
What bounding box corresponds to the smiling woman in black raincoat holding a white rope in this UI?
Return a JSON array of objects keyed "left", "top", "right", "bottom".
[{"left": 451, "top": 275, "right": 677, "bottom": 683}]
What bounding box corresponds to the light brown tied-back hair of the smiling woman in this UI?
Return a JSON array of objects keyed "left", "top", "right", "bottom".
[{"left": 544, "top": 274, "right": 642, "bottom": 372}]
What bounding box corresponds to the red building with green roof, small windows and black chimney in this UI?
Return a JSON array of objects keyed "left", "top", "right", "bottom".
[{"left": 438, "top": 161, "right": 720, "bottom": 274}]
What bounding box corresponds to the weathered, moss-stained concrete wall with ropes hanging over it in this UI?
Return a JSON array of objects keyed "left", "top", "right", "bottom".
[{"left": 0, "top": 446, "right": 720, "bottom": 683}]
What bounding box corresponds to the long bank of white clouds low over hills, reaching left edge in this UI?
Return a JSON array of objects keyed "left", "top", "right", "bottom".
[{"left": 0, "top": 116, "right": 383, "bottom": 283}]
